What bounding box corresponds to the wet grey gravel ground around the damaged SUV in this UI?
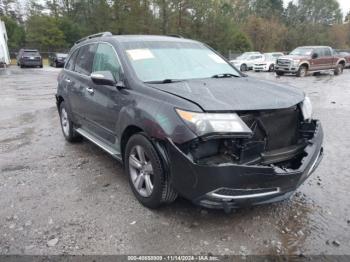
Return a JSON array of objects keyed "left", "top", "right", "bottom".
[{"left": 0, "top": 66, "right": 350, "bottom": 255}]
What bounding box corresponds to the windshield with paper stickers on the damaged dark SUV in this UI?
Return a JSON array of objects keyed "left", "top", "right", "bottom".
[{"left": 123, "top": 41, "right": 240, "bottom": 82}]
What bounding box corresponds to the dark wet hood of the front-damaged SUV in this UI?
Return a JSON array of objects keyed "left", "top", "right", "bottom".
[{"left": 148, "top": 77, "right": 304, "bottom": 111}]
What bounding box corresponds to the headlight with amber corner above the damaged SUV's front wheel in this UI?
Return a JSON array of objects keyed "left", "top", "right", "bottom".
[{"left": 176, "top": 109, "right": 252, "bottom": 137}]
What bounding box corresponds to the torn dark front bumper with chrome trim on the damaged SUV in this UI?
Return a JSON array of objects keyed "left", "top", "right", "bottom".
[{"left": 167, "top": 122, "right": 323, "bottom": 209}]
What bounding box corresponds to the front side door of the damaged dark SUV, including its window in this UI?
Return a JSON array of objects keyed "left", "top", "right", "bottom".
[{"left": 87, "top": 43, "right": 123, "bottom": 144}]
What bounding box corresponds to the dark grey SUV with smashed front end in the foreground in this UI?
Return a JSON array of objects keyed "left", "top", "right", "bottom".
[{"left": 56, "top": 33, "right": 323, "bottom": 210}]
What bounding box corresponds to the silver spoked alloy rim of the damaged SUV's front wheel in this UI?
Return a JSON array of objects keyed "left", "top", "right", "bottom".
[{"left": 129, "top": 145, "right": 154, "bottom": 197}]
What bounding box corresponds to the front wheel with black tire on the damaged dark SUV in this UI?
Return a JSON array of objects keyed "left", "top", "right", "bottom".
[{"left": 124, "top": 134, "right": 177, "bottom": 208}]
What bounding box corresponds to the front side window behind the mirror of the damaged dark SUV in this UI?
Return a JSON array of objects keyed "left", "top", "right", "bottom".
[{"left": 92, "top": 43, "right": 121, "bottom": 81}]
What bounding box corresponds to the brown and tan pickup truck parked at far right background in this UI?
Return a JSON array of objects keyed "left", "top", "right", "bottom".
[{"left": 275, "top": 46, "right": 345, "bottom": 77}]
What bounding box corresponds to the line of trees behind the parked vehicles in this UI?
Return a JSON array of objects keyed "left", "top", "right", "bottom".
[{"left": 0, "top": 0, "right": 350, "bottom": 55}]
